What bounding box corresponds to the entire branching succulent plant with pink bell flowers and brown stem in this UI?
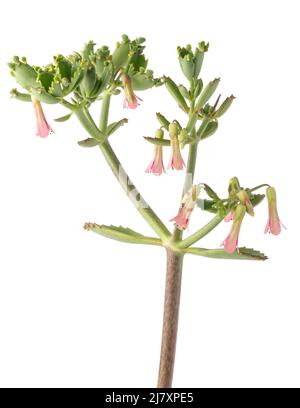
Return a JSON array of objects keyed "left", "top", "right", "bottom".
[{"left": 9, "top": 35, "right": 282, "bottom": 388}]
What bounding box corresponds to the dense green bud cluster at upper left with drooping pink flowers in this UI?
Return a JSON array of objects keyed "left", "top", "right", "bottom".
[{"left": 8, "top": 35, "right": 161, "bottom": 138}]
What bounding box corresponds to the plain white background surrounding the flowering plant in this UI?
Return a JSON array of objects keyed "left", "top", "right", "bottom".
[{"left": 0, "top": 0, "right": 300, "bottom": 387}]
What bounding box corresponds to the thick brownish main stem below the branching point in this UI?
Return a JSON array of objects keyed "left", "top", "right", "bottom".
[{"left": 157, "top": 249, "right": 183, "bottom": 388}]
